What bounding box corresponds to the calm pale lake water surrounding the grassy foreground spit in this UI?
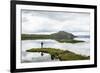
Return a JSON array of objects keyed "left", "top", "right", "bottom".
[{"left": 21, "top": 38, "right": 90, "bottom": 63}]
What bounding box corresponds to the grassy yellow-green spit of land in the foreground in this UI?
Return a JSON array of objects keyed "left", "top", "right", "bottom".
[{"left": 27, "top": 48, "right": 90, "bottom": 61}]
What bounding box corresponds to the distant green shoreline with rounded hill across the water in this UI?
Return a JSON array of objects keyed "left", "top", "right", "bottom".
[{"left": 21, "top": 31, "right": 84, "bottom": 43}]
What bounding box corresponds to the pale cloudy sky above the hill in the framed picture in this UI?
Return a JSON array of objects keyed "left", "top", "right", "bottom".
[{"left": 21, "top": 10, "right": 90, "bottom": 34}]
